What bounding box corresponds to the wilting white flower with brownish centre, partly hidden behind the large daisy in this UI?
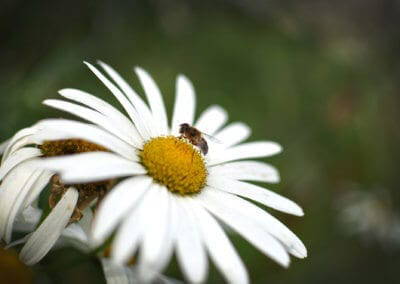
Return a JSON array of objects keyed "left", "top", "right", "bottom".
[{"left": 0, "top": 126, "right": 115, "bottom": 265}]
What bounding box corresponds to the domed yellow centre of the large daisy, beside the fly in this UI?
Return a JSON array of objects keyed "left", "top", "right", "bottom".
[{"left": 140, "top": 136, "right": 207, "bottom": 195}]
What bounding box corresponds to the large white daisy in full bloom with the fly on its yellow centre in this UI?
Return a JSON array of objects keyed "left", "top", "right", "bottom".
[{"left": 39, "top": 62, "right": 307, "bottom": 283}]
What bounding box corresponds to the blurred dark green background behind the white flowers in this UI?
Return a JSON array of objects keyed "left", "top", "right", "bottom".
[{"left": 0, "top": 0, "right": 400, "bottom": 284}]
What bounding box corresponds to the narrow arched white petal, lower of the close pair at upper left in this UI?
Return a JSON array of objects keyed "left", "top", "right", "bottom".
[{"left": 43, "top": 100, "right": 141, "bottom": 148}]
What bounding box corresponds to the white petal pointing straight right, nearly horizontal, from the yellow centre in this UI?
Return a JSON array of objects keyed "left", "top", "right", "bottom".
[{"left": 208, "top": 161, "right": 280, "bottom": 183}]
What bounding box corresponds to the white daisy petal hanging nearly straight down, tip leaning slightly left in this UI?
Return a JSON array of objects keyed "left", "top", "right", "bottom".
[{"left": 138, "top": 184, "right": 172, "bottom": 282}]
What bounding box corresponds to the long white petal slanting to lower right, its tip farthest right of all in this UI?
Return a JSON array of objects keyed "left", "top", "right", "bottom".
[{"left": 202, "top": 191, "right": 307, "bottom": 258}]
